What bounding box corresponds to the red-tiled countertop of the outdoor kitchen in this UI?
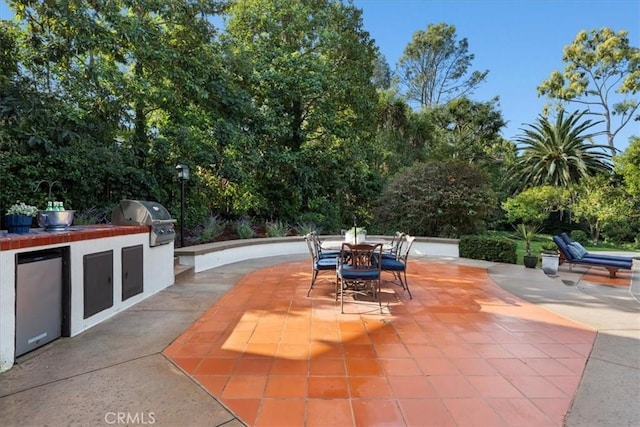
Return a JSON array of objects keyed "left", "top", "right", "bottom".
[{"left": 0, "top": 224, "right": 149, "bottom": 251}]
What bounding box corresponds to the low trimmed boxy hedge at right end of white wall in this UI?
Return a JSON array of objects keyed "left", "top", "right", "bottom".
[{"left": 458, "top": 235, "right": 518, "bottom": 264}]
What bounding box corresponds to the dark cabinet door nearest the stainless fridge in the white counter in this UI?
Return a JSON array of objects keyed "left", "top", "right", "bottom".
[{"left": 83, "top": 251, "right": 113, "bottom": 319}]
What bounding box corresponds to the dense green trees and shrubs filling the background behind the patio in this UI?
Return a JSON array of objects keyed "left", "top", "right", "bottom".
[{"left": 0, "top": 0, "right": 640, "bottom": 247}]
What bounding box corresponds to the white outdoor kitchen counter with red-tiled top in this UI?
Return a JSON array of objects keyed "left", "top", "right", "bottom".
[{"left": 0, "top": 224, "right": 174, "bottom": 372}]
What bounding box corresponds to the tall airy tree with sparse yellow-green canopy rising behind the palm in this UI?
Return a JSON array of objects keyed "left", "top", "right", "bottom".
[{"left": 538, "top": 27, "right": 640, "bottom": 150}]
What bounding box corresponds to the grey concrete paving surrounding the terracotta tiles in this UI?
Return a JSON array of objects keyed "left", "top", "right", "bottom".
[{"left": 0, "top": 255, "right": 640, "bottom": 426}]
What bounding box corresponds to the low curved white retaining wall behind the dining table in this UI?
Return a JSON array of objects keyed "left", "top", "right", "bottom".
[{"left": 174, "top": 236, "right": 459, "bottom": 273}]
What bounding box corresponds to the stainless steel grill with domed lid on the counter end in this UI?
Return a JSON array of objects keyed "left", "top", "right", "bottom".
[{"left": 111, "top": 200, "right": 176, "bottom": 246}]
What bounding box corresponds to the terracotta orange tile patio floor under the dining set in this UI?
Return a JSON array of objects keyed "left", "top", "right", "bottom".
[{"left": 164, "top": 261, "right": 595, "bottom": 427}]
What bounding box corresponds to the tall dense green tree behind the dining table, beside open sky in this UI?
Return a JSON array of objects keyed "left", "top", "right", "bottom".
[{"left": 227, "top": 0, "right": 376, "bottom": 222}]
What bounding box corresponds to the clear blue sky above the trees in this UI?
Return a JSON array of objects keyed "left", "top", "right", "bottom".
[{"left": 0, "top": 0, "right": 640, "bottom": 149}]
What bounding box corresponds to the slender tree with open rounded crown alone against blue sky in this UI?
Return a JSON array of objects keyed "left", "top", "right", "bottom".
[{"left": 398, "top": 23, "right": 489, "bottom": 107}]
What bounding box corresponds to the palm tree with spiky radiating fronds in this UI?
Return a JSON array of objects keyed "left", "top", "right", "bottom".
[{"left": 511, "top": 111, "right": 612, "bottom": 190}]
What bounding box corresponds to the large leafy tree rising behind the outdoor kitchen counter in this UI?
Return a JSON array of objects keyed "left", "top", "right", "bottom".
[{"left": 2, "top": 0, "right": 241, "bottom": 221}]
